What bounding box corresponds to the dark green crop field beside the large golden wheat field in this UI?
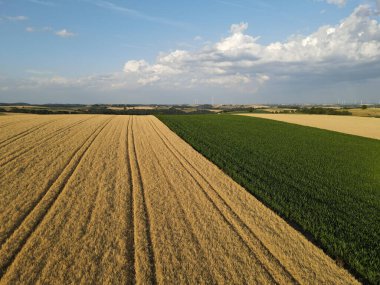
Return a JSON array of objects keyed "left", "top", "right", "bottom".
[{"left": 159, "top": 115, "right": 380, "bottom": 284}]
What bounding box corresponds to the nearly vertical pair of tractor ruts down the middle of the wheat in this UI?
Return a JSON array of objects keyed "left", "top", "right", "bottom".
[{"left": 129, "top": 116, "right": 157, "bottom": 284}]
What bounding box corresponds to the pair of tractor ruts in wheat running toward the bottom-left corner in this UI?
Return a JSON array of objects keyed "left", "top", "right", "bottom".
[{"left": 0, "top": 115, "right": 112, "bottom": 280}]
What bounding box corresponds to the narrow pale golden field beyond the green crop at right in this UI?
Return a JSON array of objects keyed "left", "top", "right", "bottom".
[{"left": 241, "top": 114, "right": 380, "bottom": 139}]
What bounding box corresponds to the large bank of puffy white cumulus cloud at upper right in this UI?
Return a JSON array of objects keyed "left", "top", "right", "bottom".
[{"left": 124, "top": 5, "right": 380, "bottom": 92}]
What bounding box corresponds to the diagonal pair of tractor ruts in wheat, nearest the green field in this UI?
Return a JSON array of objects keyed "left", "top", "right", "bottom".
[{"left": 149, "top": 116, "right": 300, "bottom": 284}]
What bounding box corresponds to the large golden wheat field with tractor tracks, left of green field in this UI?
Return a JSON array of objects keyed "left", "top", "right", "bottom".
[{"left": 0, "top": 115, "right": 357, "bottom": 284}]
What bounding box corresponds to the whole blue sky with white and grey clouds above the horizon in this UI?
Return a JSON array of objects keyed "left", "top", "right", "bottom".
[{"left": 0, "top": 0, "right": 380, "bottom": 104}]
